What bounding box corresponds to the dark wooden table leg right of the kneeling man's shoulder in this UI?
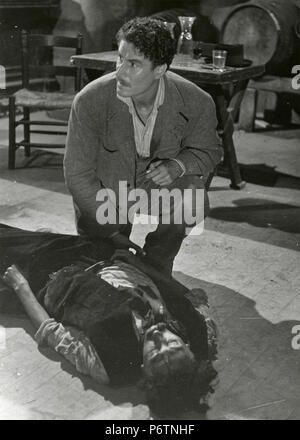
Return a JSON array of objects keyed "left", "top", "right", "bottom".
[{"left": 214, "top": 81, "right": 247, "bottom": 189}]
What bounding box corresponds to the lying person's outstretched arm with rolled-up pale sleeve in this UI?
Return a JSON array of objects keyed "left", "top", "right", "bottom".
[{"left": 3, "top": 265, "right": 109, "bottom": 384}]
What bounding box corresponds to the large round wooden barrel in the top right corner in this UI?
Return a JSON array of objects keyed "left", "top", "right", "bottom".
[{"left": 221, "top": 0, "right": 299, "bottom": 73}]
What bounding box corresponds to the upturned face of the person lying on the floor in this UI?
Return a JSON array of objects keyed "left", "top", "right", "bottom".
[{"left": 143, "top": 323, "right": 194, "bottom": 378}]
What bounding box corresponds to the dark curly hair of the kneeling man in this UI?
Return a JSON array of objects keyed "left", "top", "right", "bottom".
[{"left": 116, "top": 17, "right": 175, "bottom": 68}]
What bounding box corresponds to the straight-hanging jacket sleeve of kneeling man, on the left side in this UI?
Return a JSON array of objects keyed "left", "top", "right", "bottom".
[{"left": 64, "top": 93, "right": 118, "bottom": 237}]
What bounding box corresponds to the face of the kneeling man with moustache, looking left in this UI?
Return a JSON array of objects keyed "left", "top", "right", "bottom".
[{"left": 116, "top": 40, "right": 164, "bottom": 98}]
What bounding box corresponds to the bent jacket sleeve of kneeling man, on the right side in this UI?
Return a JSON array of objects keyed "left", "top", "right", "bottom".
[{"left": 176, "top": 91, "right": 223, "bottom": 181}]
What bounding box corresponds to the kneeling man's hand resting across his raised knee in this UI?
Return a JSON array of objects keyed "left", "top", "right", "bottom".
[{"left": 146, "top": 159, "right": 182, "bottom": 186}]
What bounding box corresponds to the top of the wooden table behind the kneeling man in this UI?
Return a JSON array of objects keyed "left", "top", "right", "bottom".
[{"left": 71, "top": 51, "right": 265, "bottom": 84}]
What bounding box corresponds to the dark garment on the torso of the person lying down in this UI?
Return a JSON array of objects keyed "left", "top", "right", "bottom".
[{"left": 38, "top": 266, "right": 208, "bottom": 383}]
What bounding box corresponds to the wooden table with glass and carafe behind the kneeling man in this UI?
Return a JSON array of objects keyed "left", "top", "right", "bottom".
[{"left": 71, "top": 51, "right": 265, "bottom": 189}]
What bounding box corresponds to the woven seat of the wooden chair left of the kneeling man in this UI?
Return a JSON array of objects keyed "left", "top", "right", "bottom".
[{"left": 14, "top": 89, "right": 75, "bottom": 110}]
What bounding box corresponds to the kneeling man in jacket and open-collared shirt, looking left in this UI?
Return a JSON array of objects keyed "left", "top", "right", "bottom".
[{"left": 64, "top": 17, "right": 222, "bottom": 273}]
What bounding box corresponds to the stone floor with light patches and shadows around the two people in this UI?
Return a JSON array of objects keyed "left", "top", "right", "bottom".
[{"left": 0, "top": 112, "right": 300, "bottom": 420}]
